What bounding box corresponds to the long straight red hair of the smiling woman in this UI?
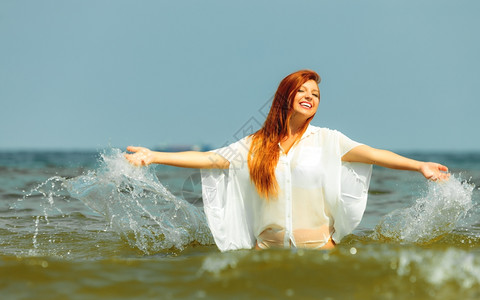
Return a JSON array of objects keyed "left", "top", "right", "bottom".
[{"left": 248, "top": 70, "right": 321, "bottom": 200}]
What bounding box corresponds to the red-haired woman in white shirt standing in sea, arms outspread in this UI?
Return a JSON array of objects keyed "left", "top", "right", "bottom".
[{"left": 125, "top": 70, "right": 449, "bottom": 251}]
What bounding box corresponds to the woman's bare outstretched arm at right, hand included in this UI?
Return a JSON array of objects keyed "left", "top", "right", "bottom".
[{"left": 342, "top": 145, "right": 450, "bottom": 180}]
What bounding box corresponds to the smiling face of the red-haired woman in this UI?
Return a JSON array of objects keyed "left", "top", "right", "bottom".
[{"left": 292, "top": 80, "right": 320, "bottom": 119}]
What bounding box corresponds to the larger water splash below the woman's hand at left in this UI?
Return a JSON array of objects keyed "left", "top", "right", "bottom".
[{"left": 64, "top": 149, "right": 213, "bottom": 254}]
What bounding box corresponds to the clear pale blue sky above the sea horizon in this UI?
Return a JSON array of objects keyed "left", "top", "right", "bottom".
[{"left": 0, "top": 0, "right": 480, "bottom": 151}]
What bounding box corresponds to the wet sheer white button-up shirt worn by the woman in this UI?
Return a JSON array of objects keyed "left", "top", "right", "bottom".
[{"left": 202, "top": 125, "right": 371, "bottom": 251}]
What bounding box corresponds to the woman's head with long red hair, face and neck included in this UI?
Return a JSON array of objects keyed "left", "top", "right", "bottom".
[{"left": 248, "top": 70, "right": 320, "bottom": 199}]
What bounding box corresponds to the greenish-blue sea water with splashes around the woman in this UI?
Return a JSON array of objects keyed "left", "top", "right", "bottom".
[{"left": 0, "top": 149, "right": 480, "bottom": 299}]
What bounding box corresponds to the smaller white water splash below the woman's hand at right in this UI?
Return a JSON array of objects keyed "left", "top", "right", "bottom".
[{"left": 373, "top": 176, "right": 474, "bottom": 244}]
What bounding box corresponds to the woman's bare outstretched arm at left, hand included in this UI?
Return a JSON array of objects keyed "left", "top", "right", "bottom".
[{"left": 125, "top": 146, "right": 230, "bottom": 169}]
